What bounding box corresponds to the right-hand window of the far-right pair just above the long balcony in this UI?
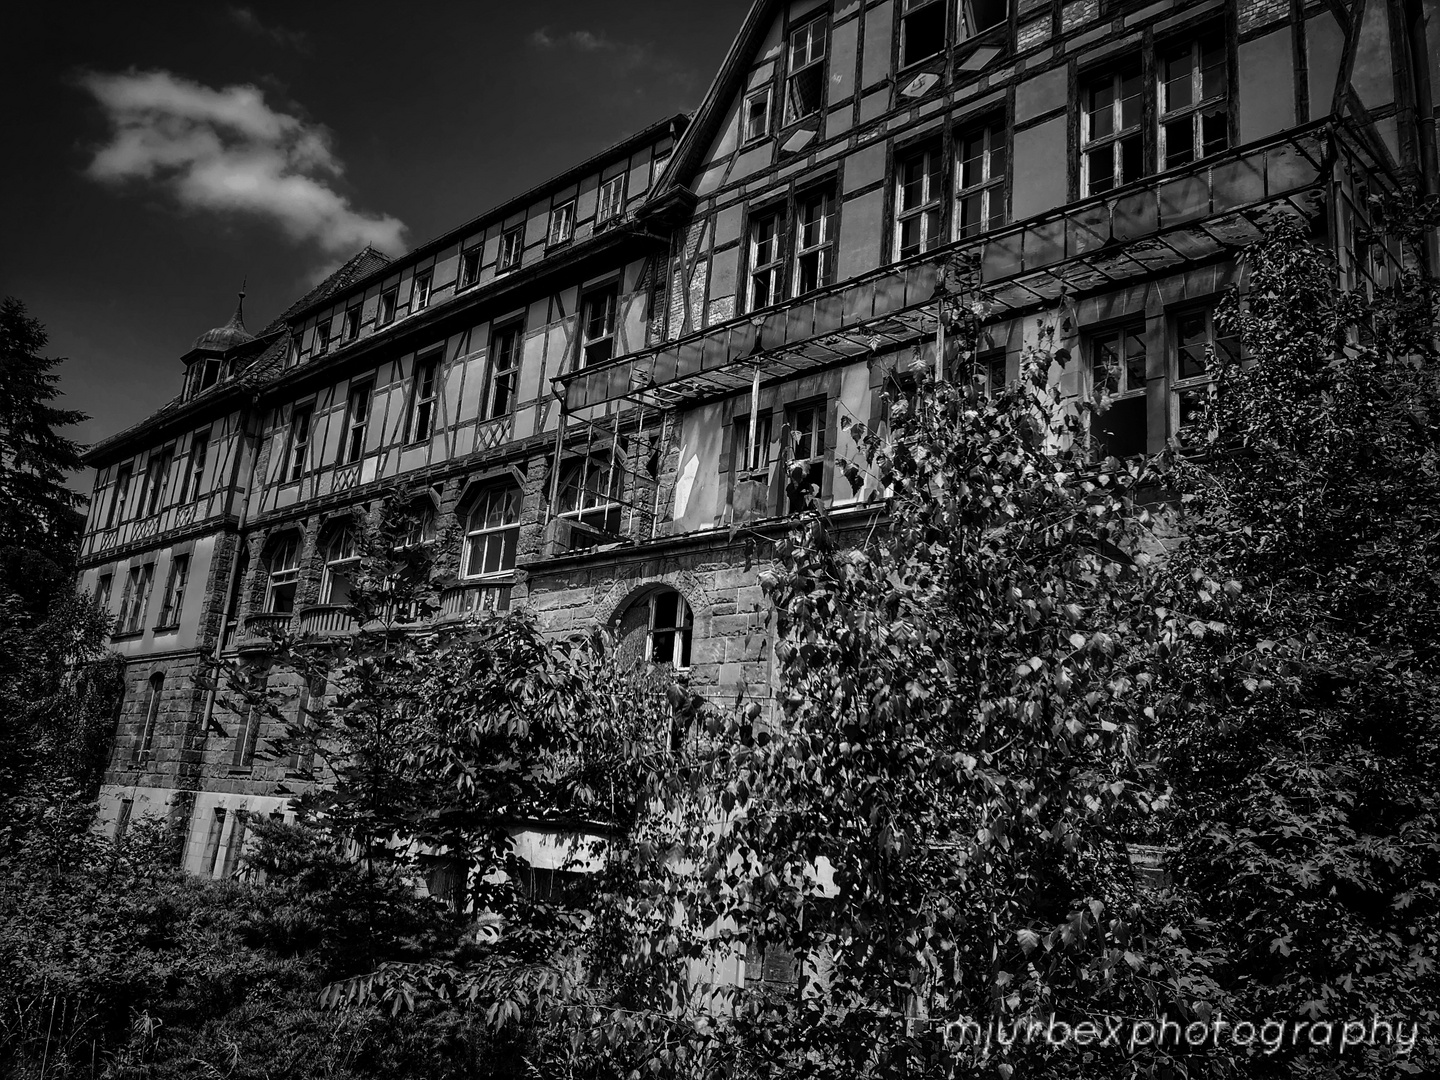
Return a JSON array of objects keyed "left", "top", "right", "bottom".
[{"left": 1159, "top": 33, "right": 1230, "bottom": 168}]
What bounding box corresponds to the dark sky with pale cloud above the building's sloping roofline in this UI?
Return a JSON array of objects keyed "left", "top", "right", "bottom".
[{"left": 0, "top": 0, "right": 749, "bottom": 491}]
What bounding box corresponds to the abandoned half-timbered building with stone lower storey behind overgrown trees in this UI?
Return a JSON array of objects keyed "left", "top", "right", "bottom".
[{"left": 81, "top": 0, "right": 1440, "bottom": 876}]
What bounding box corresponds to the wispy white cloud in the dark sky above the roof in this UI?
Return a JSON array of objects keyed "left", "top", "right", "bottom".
[{"left": 79, "top": 71, "right": 406, "bottom": 255}]
